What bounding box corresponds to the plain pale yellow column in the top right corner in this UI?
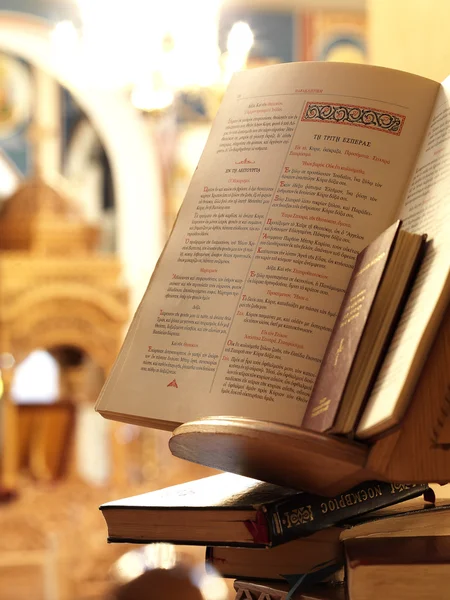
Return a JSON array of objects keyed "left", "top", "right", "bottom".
[{"left": 367, "top": 0, "right": 450, "bottom": 81}]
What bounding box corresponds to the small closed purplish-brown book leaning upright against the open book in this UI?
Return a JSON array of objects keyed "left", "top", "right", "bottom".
[{"left": 302, "top": 221, "right": 426, "bottom": 434}]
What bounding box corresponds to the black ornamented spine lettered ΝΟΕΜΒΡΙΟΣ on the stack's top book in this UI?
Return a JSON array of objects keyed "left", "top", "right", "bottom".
[{"left": 259, "top": 481, "right": 429, "bottom": 546}]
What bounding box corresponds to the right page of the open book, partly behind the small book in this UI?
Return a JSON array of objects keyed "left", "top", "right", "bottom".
[{"left": 356, "top": 77, "right": 450, "bottom": 439}]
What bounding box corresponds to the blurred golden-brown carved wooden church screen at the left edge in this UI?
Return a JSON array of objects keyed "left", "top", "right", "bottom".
[{"left": 0, "top": 177, "right": 129, "bottom": 489}]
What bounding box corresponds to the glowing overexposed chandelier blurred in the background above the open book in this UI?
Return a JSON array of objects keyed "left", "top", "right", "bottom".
[{"left": 52, "top": 0, "right": 253, "bottom": 111}]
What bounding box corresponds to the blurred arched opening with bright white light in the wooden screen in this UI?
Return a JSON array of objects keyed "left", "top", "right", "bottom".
[{"left": 11, "top": 345, "right": 111, "bottom": 485}]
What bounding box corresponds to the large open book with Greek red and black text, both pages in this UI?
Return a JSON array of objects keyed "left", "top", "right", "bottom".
[{"left": 96, "top": 63, "right": 450, "bottom": 438}]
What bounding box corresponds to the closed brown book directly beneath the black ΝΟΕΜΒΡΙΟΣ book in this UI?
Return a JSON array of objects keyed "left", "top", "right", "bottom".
[{"left": 205, "top": 527, "right": 343, "bottom": 580}]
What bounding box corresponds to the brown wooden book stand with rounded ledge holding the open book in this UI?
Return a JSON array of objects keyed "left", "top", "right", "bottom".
[{"left": 169, "top": 309, "right": 450, "bottom": 495}]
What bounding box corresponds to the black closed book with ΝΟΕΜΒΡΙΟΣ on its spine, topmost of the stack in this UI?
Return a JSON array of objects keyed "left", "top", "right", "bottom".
[{"left": 100, "top": 473, "right": 428, "bottom": 547}]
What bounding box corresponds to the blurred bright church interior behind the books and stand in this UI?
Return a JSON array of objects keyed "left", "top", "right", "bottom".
[{"left": 0, "top": 0, "right": 450, "bottom": 600}]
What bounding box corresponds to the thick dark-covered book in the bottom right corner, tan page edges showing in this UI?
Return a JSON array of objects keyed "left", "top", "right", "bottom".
[{"left": 344, "top": 536, "right": 450, "bottom": 600}]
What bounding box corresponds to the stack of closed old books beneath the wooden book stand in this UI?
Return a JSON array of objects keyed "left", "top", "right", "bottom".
[{"left": 101, "top": 473, "right": 450, "bottom": 599}]
